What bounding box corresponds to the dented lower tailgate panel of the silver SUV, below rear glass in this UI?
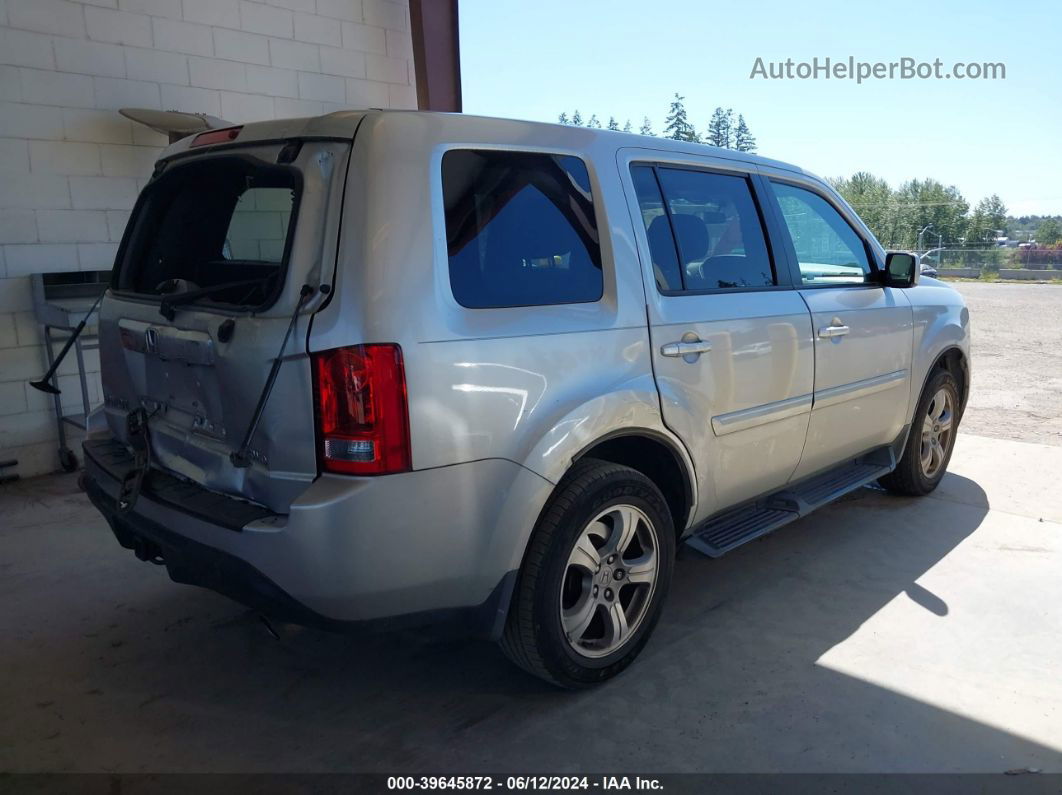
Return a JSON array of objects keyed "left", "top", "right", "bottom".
[{"left": 100, "top": 304, "right": 316, "bottom": 513}]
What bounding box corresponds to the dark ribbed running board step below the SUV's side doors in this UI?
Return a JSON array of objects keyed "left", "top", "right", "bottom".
[{"left": 686, "top": 448, "right": 895, "bottom": 557}]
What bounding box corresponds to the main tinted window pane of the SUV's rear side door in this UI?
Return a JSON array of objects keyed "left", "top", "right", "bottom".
[{"left": 656, "top": 168, "right": 775, "bottom": 290}]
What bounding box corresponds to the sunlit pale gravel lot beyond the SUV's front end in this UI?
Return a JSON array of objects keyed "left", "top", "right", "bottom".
[{"left": 952, "top": 281, "right": 1062, "bottom": 447}]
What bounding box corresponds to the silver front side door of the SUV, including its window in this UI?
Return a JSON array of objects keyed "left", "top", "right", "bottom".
[{"left": 770, "top": 177, "right": 912, "bottom": 479}]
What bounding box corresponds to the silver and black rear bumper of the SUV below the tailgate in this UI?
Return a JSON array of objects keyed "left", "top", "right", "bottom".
[{"left": 84, "top": 443, "right": 551, "bottom": 637}]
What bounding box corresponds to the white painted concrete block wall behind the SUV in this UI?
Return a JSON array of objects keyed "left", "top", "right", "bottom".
[{"left": 0, "top": 0, "right": 416, "bottom": 477}]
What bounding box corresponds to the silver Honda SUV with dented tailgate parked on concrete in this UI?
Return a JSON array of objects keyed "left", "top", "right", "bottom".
[{"left": 84, "top": 110, "right": 970, "bottom": 687}]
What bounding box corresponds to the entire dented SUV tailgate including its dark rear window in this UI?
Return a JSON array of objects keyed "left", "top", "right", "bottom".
[{"left": 100, "top": 140, "right": 349, "bottom": 512}]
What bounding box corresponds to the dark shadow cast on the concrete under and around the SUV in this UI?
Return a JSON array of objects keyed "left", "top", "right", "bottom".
[{"left": 0, "top": 476, "right": 1062, "bottom": 773}]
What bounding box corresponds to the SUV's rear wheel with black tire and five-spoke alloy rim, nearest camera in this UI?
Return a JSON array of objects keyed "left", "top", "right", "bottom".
[{"left": 501, "top": 460, "right": 675, "bottom": 688}]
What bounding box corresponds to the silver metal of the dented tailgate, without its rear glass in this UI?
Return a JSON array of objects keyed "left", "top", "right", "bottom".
[{"left": 99, "top": 141, "right": 349, "bottom": 513}]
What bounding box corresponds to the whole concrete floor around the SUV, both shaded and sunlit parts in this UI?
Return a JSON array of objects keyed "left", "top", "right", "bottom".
[{"left": 0, "top": 435, "right": 1062, "bottom": 773}]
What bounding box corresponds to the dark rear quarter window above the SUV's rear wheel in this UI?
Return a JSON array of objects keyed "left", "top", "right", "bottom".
[{"left": 443, "top": 150, "right": 603, "bottom": 309}]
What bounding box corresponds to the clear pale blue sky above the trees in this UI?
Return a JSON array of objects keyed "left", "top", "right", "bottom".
[{"left": 460, "top": 0, "right": 1062, "bottom": 215}]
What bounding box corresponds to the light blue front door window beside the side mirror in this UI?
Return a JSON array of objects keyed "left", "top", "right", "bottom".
[{"left": 772, "top": 183, "right": 871, "bottom": 284}]
